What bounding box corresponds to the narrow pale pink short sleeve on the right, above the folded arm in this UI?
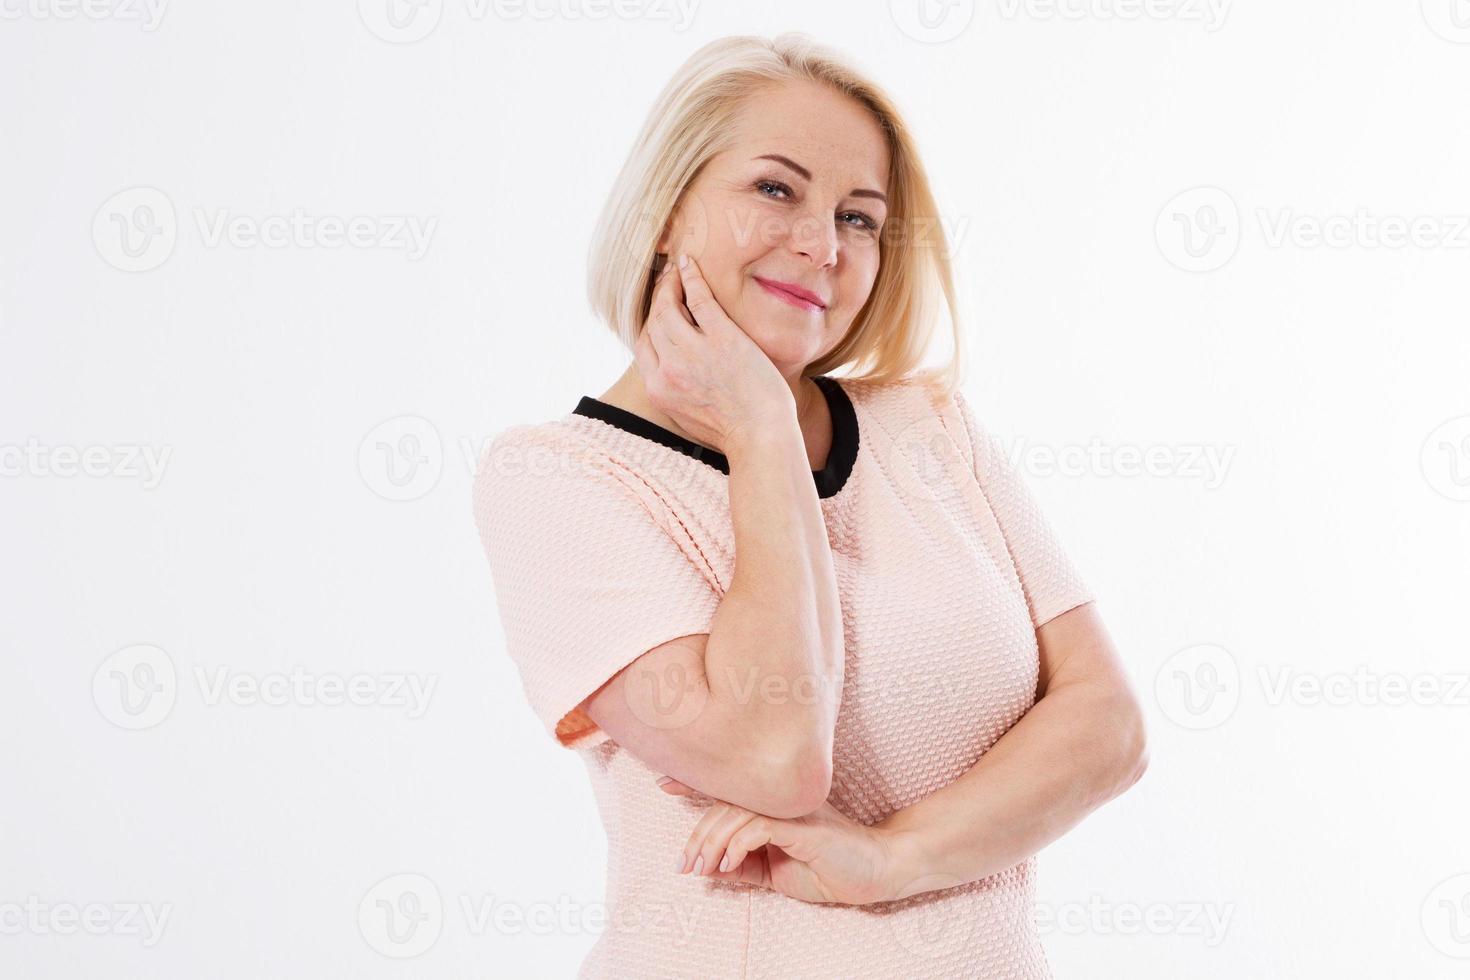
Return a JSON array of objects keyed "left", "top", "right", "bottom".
[{"left": 954, "top": 391, "right": 1094, "bottom": 629}]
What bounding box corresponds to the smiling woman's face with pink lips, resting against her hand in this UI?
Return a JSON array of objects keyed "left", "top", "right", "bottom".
[{"left": 659, "top": 82, "right": 888, "bottom": 378}]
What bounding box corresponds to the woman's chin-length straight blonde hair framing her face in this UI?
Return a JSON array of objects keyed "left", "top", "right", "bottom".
[{"left": 587, "top": 32, "right": 964, "bottom": 395}]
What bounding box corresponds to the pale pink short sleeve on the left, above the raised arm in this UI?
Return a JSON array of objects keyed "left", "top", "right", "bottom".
[{"left": 473, "top": 426, "right": 720, "bottom": 749}]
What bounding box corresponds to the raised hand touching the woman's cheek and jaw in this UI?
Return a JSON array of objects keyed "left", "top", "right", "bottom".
[{"left": 634, "top": 256, "right": 795, "bottom": 453}]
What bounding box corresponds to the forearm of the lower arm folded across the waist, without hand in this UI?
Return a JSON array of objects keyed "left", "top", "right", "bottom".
[{"left": 878, "top": 685, "right": 1147, "bottom": 898}]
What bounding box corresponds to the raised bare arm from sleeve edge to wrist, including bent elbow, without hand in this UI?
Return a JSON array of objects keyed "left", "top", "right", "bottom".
[{"left": 585, "top": 404, "right": 844, "bottom": 817}]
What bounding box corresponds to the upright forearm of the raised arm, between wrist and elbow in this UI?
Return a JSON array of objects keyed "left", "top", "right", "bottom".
[{"left": 706, "top": 410, "right": 844, "bottom": 767}]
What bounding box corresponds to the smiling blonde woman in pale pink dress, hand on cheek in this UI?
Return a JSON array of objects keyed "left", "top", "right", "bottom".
[{"left": 475, "top": 35, "right": 1147, "bottom": 980}]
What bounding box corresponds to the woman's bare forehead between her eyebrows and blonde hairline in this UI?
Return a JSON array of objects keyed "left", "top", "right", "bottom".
[{"left": 725, "top": 82, "right": 888, "bottom": 191}]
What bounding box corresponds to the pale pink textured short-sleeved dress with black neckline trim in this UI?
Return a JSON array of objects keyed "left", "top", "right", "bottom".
[{"left": 473, "top": 378, "right": 1092, "bottom": 980}]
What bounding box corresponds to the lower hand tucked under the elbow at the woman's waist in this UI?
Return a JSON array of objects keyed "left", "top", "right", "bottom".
[{"left": 663, "top": 779, "right": 898, "bottom": 905}]
